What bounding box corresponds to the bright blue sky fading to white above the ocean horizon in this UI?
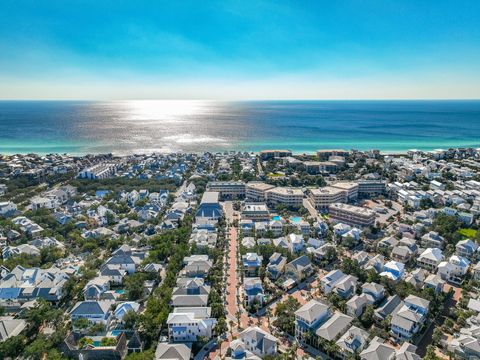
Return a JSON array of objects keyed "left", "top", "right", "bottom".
[{"left": 0, "top": 0, "right": 480, "bottom": 99}]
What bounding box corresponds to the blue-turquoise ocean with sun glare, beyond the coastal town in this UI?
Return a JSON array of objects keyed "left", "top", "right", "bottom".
[{"left": 0, "top": 100, "right": 480, "bottom": 155}]
